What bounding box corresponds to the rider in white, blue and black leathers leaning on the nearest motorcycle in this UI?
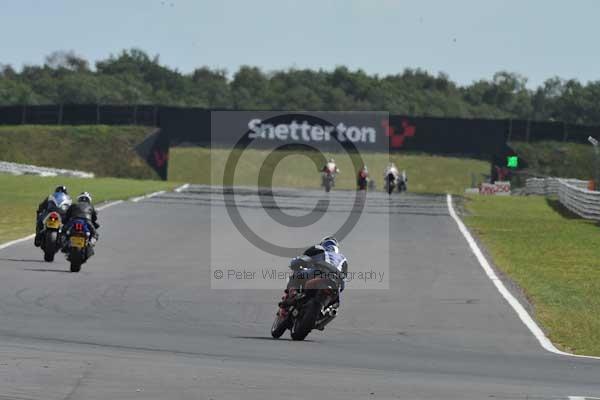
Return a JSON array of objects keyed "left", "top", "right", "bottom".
[{"left": 279, "top": 236, "right": 348, "bottom": 313}]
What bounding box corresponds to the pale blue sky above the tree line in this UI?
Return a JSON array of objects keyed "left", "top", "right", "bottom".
[{"left": 0, "top": 0, "right": 600, "bottom": 86}]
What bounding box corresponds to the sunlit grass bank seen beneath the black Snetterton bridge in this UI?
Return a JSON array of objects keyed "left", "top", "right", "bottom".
[{"left": 169, "top": 147, "right": 489, "bottom": 194}]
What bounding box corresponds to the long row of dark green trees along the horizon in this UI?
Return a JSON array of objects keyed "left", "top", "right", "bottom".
[{"left": 0, "top": 49, "right": 600, "bottom": 125}]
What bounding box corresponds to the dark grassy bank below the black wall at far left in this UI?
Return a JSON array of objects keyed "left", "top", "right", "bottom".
[{"left": 0, "top": 125, "right": 158, "bottom": 179}]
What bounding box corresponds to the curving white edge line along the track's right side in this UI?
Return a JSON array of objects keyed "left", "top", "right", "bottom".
[{"left": 446, "top": 194, "right": 600, "bottom": 360}]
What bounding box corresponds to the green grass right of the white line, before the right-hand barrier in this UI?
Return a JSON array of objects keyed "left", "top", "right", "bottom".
[{"left": 464, "top": 196, "right": 600, "bottom": 356}]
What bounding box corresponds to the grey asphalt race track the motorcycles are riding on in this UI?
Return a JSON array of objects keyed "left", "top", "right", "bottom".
[{"left": 0, "top": 186, "right": 600, "bottom": 400}]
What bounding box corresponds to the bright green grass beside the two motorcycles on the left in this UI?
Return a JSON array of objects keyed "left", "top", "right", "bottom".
[{"left": 0, "top": 174, "right": 176, "bottom": 243}]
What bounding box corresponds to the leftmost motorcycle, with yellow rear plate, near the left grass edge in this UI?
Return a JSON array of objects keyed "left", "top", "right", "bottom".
[{"left": 40, "top": 192, "right": 71, "bottom": 262}]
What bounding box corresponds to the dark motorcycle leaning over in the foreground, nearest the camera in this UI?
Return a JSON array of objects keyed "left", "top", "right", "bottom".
[{"left": 271, "top": 257, "right": 340, "bottom": 340}]
